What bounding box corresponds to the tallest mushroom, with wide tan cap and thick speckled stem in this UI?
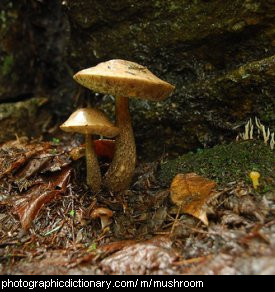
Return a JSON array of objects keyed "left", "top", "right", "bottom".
[{"left": 74, "top": 59, "right": 174, "bottom": 191}]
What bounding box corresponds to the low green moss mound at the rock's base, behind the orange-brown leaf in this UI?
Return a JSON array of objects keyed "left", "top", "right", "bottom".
[{"left": 159, "top": 140, "right": 275, "bottom": 189}]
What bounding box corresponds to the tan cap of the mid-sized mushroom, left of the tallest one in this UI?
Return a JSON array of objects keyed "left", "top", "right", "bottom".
[{"left": 60, "top": 108, "right": 119, "bottom": 138}]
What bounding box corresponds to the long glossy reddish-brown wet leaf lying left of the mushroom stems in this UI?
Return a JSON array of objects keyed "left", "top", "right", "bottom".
[{"left": 12, "top": 167, "right": 72, "bottom": 230}]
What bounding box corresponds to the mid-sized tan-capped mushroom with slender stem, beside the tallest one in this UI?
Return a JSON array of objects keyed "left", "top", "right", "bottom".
[{"left": 60, "top": 108, "right": 119, "bottom": 192}]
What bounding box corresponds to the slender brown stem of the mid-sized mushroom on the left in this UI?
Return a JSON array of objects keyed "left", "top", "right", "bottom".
[{"left": 85, "top": 134, "right": 101, "bottom": 193}]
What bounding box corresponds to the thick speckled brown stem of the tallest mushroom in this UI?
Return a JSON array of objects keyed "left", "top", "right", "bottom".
[{"left": 105, "top": 97, "right": 136, "bottom": 192}]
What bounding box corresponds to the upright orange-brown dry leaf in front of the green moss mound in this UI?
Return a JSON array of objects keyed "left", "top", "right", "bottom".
[{"left": 170, "top": 173, "right": 216, "bottom": 225}]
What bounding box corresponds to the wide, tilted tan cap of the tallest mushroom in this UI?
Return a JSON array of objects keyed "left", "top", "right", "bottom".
[{"left": 74, "top": 59, "right": 174, "bottom": 101}]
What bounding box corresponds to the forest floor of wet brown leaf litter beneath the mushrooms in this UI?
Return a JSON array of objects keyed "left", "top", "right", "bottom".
[{"left": 0, "top": 138, "right": 275, "bottom": 275}]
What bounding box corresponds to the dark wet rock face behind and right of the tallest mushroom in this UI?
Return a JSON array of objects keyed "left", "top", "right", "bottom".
[{"left": 65, "top": 0, "right": 275, "bottom": 157}]
